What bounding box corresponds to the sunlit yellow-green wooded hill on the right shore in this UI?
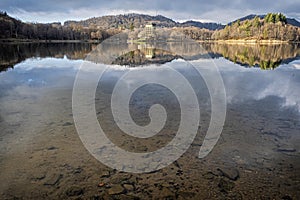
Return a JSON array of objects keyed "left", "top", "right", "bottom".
[{"left": 212, "top": 13, "right": 300, "bottom": 42}]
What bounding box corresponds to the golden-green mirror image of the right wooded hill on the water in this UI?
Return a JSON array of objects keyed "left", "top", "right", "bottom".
[{"left": 206, "top": 44, "right": 300, "bottom": 69}]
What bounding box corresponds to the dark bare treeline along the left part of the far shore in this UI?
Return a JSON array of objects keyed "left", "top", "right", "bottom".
[{"left": 0, "top": 12, "right": 119, "bottom": 40}]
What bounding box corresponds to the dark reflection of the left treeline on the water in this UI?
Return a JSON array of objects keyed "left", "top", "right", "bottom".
[{"left": 0, "top": 43, "right": 92, "bottom": 71}]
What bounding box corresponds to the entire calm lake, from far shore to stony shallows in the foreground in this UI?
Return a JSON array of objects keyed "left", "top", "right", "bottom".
[{"left": 0, "top": 39, "right": 300, "bottom": 199}]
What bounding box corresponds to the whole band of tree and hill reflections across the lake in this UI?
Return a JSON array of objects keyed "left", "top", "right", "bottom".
[{"left": 0, "top": 37, "right": 300, "bottom": 71}]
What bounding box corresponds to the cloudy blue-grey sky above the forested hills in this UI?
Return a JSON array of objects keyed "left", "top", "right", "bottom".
[{"left": 0, "top": 0, "right": 300, "bottom": 24}]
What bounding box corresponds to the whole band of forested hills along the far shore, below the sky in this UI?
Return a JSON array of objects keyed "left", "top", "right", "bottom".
[{"left": 0, "top": 12, "right": 300, "bottom": 42}]
